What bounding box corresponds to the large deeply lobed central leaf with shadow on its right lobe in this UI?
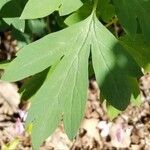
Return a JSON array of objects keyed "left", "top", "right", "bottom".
[{"left": 3, "top": 12, "right": 142, "bottom": 149}]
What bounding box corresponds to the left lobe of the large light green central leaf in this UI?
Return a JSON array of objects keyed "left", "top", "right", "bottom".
[{"left": 3, "top": 25, "right": 77, "bottom": 81}]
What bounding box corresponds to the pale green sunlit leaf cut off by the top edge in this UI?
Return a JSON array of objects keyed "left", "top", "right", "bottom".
[{"left": 21, "top": 0, "right": 82, "bottom": 19}]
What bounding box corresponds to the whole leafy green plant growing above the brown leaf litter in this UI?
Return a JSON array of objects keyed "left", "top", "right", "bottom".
[{"left": 0, "top": 0, "right": 150, "bottom": 149}]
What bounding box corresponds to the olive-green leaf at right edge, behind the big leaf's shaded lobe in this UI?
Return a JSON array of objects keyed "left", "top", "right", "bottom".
[{"left": 120, "top": 35, "right": 150, "bottom": 72}]
